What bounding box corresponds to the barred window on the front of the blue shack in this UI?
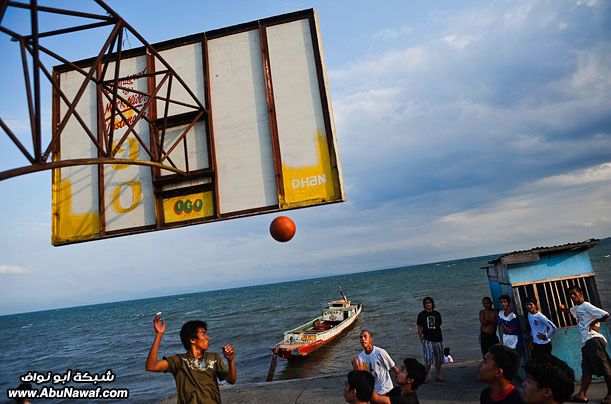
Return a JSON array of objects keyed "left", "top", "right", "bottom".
[{"left": 513, "top": 274, "right": 601, "bottom": 327}]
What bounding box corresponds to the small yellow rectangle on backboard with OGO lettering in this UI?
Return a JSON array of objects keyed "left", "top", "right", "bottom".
[{"left": 163, "top": 191, "right": 214, "bottom": 223}]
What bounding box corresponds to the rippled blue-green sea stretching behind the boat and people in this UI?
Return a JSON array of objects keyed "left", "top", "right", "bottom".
[{"left": 0, "top": 239, "right": 611, "bottom": 403}]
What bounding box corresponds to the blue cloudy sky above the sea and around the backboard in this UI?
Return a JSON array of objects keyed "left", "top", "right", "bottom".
[{"left": 0, "top": 0, "right": 611, "bottom": 314}]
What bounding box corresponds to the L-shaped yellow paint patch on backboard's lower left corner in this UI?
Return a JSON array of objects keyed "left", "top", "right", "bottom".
[{"left": 51, "top": 174, "right": 100, "bottom": 245}]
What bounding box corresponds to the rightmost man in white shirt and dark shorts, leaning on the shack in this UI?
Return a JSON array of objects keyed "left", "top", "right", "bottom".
[{"left": 558, "top": 286, "right": 611, "bottom": 404}]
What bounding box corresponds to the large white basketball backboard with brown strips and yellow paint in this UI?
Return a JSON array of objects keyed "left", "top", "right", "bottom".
[{"left": 52, "top": 10, "right": 345, "bottom": 245}]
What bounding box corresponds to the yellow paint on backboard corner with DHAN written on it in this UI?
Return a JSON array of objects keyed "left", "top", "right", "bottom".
[{"left": 280, "top": 132, "right": 339, "bottom": 209}]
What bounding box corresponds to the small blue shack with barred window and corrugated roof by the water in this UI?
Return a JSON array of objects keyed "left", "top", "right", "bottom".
[{"left": 482, "top": 239, "right": 609, "bottom": 380}]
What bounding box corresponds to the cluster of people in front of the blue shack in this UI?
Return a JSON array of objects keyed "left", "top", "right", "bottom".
[{"left": 479, "top": 286, "right": 611, "bottom": 404}]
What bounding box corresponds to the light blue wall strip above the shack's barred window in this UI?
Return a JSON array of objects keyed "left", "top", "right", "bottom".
[{"left": 508, "top": 251, "right": 594, "bottom": 284}]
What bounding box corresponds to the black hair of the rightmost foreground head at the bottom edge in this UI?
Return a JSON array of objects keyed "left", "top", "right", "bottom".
[{"left": 524, "top": 355, "right": 575, "bottom": 403}]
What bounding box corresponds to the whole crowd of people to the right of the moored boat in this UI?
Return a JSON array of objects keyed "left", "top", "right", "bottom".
[{"left": 344, "top": 286, "right": 611, "bottom": 404}]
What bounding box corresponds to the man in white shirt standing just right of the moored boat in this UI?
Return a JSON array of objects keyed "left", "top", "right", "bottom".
[{"left": 352, "top": 330, "right": 399, "bottom": 394}]
